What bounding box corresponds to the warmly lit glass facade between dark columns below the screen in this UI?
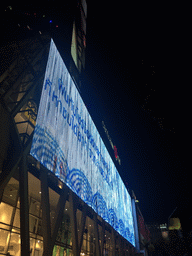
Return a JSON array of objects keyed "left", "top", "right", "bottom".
[{"left": 0, "top": 164, "right": 135, "bottom": 256}]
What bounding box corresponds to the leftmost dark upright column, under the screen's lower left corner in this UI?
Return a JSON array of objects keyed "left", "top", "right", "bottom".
[{"left": 19, "top": 154, "right": 30, "bottom": 256}]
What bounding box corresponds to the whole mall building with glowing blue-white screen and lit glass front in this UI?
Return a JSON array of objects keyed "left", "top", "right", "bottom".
[{"left": 0, "top": 1, "right": 146, "bottom": 256}]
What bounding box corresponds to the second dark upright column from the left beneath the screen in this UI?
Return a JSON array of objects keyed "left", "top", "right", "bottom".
[{"left": 40, "top": 170, "right": 51, "bottom": 256}]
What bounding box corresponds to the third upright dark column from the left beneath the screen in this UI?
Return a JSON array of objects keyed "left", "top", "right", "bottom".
[{"left": 69, "top": 191, "right": 79, "bottom": 256}]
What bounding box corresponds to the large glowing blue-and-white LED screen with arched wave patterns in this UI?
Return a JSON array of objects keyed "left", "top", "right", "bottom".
[{"left": 30, "top": 40, "right": 135, "bottom": 245}]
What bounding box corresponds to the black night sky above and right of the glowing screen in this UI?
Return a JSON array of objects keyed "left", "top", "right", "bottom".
[{"left": 1, "top": 1, "right": 191, "bottom": 223}]
